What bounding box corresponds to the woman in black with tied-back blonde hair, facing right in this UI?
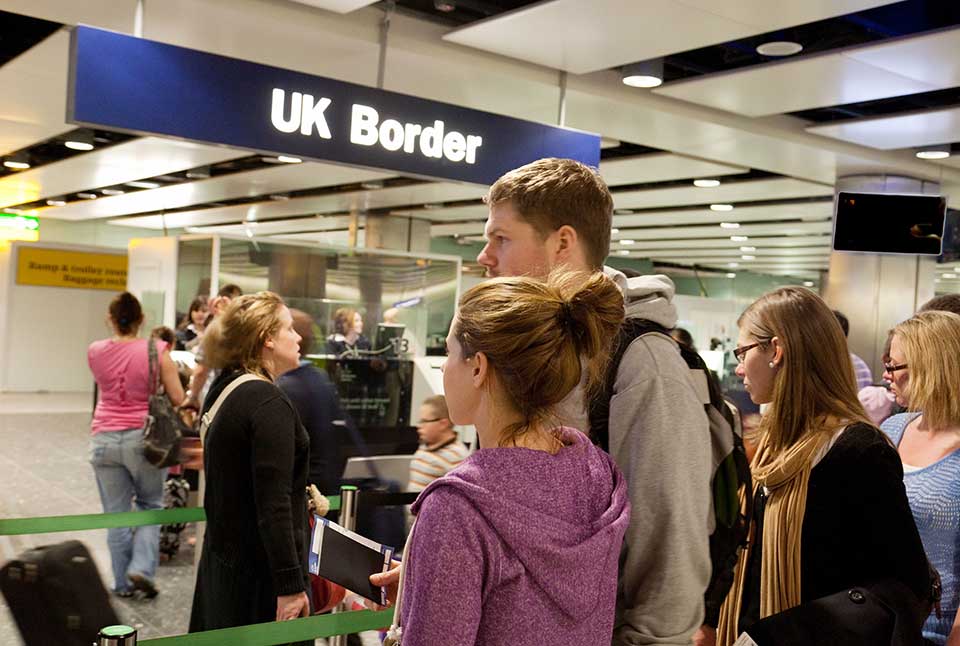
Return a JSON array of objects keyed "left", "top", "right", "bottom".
[{"left": 190, "top": 292, "right": 310, "bottom": 644}]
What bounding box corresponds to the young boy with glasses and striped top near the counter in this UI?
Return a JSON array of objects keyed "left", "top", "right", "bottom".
[{"left": 407, "top": 395, "right": 470, "bottom": 491}]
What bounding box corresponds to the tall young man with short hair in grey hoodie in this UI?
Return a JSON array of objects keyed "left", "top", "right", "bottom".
[{"left": 477, "top": 159, "right": 713, "bottom": 646}]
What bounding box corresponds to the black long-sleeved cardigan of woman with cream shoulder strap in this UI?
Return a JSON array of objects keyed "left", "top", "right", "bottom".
[{"left": 198, "top": 373, "right": 309, "bottom": 600}]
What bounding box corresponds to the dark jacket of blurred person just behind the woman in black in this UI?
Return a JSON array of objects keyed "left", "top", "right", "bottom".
[{"left": 277, "top": 361, "right": 343, "bottom": 496}]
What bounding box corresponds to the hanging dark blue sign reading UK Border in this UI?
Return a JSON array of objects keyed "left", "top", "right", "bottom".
[{"left": 67, "top": 27, "right": 600, "bottom": 184}]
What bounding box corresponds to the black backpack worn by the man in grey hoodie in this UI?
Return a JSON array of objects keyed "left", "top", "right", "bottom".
[{"left": 590, "top": 319, "right": 753, "bottom": 626}]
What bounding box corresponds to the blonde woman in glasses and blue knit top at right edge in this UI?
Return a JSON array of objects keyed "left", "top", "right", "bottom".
[{"left": 880, "top": 312, "right": 960, "bottom": 646}]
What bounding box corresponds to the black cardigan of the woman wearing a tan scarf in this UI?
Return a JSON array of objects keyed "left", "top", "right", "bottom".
[{"left": 739, "top": 424, "right": 930, "bottom": 631}]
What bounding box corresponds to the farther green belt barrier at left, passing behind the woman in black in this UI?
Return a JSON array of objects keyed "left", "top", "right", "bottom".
[{"left": 0, "top": 496, "right": 340, "bottom": 536}]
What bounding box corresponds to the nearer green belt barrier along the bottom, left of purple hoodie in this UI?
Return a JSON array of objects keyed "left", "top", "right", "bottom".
[{"left": 139, "top": 608, "right": 393, "bottom": 646}]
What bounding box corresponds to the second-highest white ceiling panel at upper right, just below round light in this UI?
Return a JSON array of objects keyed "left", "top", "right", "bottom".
[{"left": 653, "top": 54, "right": 938, "bottom": 117}]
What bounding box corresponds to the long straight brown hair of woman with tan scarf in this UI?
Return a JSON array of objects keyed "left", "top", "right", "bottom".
[{"left": 737, "top": 287, "right": 870, "bottom": 453}]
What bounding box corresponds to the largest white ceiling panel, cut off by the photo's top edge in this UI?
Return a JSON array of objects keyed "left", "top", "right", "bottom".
[{"left": 443, "top": 0, "right": 890, "bottom": 74}]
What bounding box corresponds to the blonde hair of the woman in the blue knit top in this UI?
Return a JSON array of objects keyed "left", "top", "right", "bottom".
[{"left": 893, "top": 310, "right": 960, "bottom": 428}]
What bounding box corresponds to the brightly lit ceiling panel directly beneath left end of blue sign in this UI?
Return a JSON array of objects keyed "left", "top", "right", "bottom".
[{"left": 0, "top": 137, "right": 242, "bottom": 207}]
